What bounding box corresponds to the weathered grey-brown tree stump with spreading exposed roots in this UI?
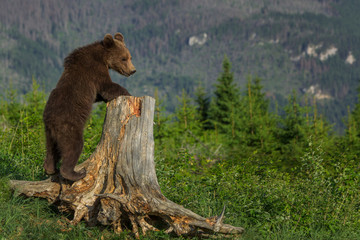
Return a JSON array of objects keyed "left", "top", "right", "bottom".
[{"left": 10, "top": 96, "right": 244, "bottom": 238}]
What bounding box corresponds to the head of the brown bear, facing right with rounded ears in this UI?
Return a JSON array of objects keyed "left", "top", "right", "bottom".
[{"left": 103, "top": 33, "right": 136, "bottom": 77}]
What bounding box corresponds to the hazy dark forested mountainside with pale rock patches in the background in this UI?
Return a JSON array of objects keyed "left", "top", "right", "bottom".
[{"left": 0, "top": 0, "right": 360, "bottom": 131}]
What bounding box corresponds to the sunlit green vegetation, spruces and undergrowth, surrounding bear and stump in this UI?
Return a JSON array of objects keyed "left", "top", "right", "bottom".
[{"left": 0, "top": 56, "right": 360, "bottom": 240}]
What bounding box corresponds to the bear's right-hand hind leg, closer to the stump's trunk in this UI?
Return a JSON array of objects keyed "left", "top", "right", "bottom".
[{"left": 60, "top": 133, "right": 86, "bottom": 182}]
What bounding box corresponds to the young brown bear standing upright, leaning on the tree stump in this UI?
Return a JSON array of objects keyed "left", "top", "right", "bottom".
[{"left": 43, "top": 33, "right": 136, "bottom": 181}]
